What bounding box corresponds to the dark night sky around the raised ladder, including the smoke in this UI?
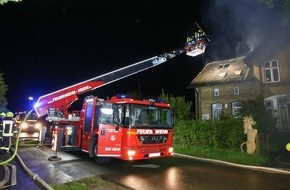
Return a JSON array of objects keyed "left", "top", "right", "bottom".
[{"left": 0, "top": 0, "right": 281, "bottom": 111}]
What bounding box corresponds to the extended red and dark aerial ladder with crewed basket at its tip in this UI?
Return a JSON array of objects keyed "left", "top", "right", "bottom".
[{"left": 34, "top": 23, "right": 209, "bottom": 122}]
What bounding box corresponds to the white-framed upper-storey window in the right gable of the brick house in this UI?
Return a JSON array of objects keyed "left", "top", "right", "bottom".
[{"left": 264, "top": 60, "right": 280, "bottom": 83}]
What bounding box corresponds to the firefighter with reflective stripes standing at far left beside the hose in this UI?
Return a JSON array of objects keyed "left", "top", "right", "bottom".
[{"left": 0, "top": 112, "right": 17, "bottom": 154}]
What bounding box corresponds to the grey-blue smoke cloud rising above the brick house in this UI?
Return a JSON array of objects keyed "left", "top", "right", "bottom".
[{"left": 202, "top": 0, "right": 284, "bottom": 62}]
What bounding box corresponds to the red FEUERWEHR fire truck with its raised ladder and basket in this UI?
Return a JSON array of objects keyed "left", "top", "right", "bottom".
[{"left": 34, "top": 27, "right": 206, "bottom": 163}]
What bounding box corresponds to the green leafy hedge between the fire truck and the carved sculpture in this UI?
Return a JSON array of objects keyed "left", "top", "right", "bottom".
[{"left": 174, "top": 118, "right": 246, "bottom": 149}]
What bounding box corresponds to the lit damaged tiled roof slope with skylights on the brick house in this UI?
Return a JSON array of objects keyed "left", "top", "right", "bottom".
[{"left": 187, "top": 56, "right": 254, "bottom": 88}]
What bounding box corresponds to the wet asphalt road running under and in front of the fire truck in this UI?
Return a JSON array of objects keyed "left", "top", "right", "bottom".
[{"left": 1, "top": 148, "right": 290, "bottom": 190}]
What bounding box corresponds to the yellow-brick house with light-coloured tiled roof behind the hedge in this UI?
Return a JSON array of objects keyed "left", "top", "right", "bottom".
[{"left": 188, "top": 26, "right": 290, "bottom": 132}]
